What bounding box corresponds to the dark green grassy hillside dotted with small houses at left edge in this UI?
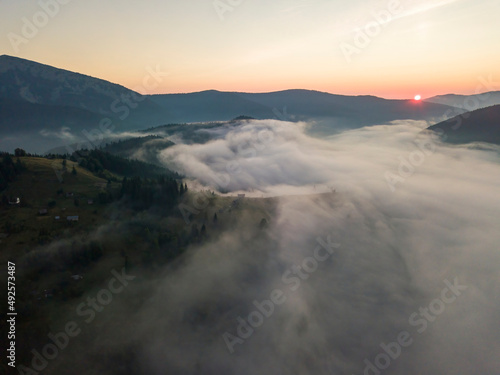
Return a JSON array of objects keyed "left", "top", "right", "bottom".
[{"left": 0, "top": 157, "right": 118, "bottom": 264}]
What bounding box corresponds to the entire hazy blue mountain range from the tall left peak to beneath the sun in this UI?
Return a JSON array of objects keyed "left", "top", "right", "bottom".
[{"left": 0, "top": 55, "right": 468, "bottom": 152}]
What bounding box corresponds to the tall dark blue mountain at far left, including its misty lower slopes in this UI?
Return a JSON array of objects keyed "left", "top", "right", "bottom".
[{"left": 0, "top": 55, "right": 176, "bottom": 152}]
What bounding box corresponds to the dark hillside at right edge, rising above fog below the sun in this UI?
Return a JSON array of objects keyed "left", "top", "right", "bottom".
[{"left": 429, "top": 105, "right": 500, "bottom": 145}]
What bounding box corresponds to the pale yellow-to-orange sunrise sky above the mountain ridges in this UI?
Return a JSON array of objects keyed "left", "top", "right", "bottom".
[{"left": 0, "top": 0, "right": 500, "bottom": 98}]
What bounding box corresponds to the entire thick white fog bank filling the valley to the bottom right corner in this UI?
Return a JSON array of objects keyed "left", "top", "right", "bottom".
[{"left": 42, "top": 121, "right": 500, "bottom": 375}]
